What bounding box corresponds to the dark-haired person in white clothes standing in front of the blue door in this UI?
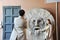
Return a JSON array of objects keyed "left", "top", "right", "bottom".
[{"left": 10, "top": 9, "right": 26, "bottom": 40}]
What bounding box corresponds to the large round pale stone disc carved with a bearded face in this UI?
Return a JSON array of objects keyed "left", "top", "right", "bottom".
[{"left": 26, "top": 8, "right": 55, "bottom": 40}]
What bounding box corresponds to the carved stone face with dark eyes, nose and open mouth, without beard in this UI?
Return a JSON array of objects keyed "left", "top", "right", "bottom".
[{"left": 29, "top": 18, "right": 47, "bottom": 30}]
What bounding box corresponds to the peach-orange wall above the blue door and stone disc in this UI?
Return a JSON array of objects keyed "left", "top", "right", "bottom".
[{"left": 0, "top": 0, "right": 56, "bottom": 39}]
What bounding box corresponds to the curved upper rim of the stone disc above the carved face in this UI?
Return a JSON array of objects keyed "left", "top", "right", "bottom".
[{"left": 26, "top": 8, "right": 55, "bottom": 25}]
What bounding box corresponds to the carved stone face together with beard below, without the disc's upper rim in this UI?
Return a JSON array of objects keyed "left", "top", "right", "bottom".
[{"left": 29, "top": 18, "right": 48, "bottom": 40}]
